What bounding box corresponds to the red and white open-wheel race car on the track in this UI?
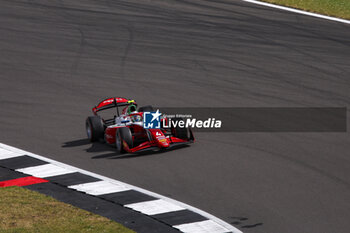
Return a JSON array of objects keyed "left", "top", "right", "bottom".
[{"left": 86, "top": 97, "right": 194, "bottom": 153}]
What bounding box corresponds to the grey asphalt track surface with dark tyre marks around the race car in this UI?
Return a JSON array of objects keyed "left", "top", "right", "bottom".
[{"left": 0, "top": 0, "right": 350, "bottom": 233}]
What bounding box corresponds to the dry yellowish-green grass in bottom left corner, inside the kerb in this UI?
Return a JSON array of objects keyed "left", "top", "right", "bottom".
[{"left": 0, "top": 187, "right": 134, "bottom": 233}]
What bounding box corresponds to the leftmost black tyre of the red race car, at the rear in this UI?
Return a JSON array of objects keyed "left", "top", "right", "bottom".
[{"left": 85, "top": 116, "right": 105, "bottom": 142}]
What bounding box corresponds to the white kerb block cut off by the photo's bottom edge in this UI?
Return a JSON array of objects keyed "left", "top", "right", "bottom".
[{"left": 173, "top": 220, "right": 231, "bottom": 233}]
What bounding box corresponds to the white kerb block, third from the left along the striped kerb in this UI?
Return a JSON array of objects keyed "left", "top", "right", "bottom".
[{"left": 68, "top": 181, "right": 130, "bottom": 195}]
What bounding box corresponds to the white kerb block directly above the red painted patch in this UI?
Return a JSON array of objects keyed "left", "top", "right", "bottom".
[{"left": 16, "top": 164, "right": 76, "bottom": 178}]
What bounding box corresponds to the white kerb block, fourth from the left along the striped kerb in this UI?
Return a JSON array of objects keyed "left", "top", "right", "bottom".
[{"left": 125, "top": 199, "right": 185, "bottom": 215}]
